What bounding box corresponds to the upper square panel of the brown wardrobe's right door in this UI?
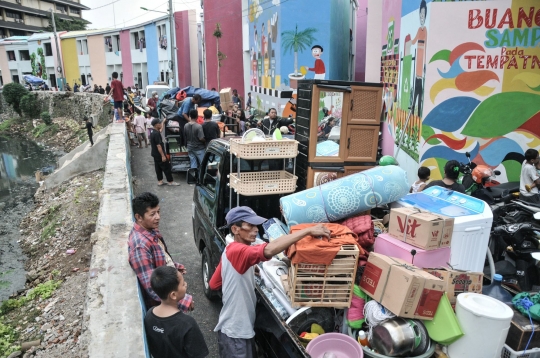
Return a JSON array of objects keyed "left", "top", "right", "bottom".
[{"left": 347, "top": 86, "right": 382, "bottom": 126}]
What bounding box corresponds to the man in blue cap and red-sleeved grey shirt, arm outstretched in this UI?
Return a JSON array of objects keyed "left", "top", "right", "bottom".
[{"left": 210, "top": 206, "right": 330, "bottom": 358}]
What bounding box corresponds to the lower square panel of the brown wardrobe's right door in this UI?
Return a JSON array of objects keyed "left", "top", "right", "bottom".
[{"left": 344, "top": 125, "right": 379, "bottom": 162}]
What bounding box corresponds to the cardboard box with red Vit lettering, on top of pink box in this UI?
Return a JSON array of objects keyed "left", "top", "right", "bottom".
[{"left": 388, "top": 208, "right": 454, "bottom": 250}]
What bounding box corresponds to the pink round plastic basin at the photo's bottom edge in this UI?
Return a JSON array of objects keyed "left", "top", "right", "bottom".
[{"left": 306, "top": 333, "right": 364, "bottom": 358}]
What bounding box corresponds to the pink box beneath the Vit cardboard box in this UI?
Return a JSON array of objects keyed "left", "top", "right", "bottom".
[{"left": 373, "top": 234, "right": 450, "bottom": 268}]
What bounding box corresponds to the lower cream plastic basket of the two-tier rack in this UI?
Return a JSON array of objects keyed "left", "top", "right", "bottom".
[{"left": 229, "top": 170, "right": 298, "bottom": 196}]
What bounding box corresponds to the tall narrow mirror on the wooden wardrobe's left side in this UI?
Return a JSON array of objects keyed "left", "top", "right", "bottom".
[{"left": 315, "top": 91, "right": 343, "bottom": 157}]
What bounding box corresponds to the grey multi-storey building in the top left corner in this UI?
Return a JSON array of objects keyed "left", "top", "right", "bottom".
[{"left": 0, "top": 0, "right": 90, "bottom": 38}]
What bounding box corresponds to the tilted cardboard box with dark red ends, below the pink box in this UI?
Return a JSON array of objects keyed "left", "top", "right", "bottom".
[{"left": 360, "top": 252, "right": 446, "bottom": 320}]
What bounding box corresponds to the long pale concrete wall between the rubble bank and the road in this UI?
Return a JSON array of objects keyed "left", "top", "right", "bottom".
[{"left": 80, "top": 123, "right": 146, "bottom": 358}]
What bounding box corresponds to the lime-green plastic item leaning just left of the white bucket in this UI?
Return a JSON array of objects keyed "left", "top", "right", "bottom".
[{"left": 422, "top": 293, "right": 463, "bottom": 345}]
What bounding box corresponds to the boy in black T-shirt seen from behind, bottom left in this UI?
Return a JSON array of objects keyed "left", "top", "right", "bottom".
[{"left": 144, "top": 266, "right": 209, "bottom": 358}]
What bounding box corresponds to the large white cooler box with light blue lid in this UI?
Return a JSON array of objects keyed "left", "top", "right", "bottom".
[{"left": 392, "top": 186, "right": 493, "bottom": 272}]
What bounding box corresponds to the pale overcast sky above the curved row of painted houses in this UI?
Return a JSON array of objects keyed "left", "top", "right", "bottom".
[{"left": 81, "top": 0, "right": 202, "bottom": 29}]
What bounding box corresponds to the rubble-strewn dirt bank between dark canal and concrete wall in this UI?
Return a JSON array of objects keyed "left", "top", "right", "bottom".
[{"left": 3, "top": 171, "right": 103, "bottom": 358}]
